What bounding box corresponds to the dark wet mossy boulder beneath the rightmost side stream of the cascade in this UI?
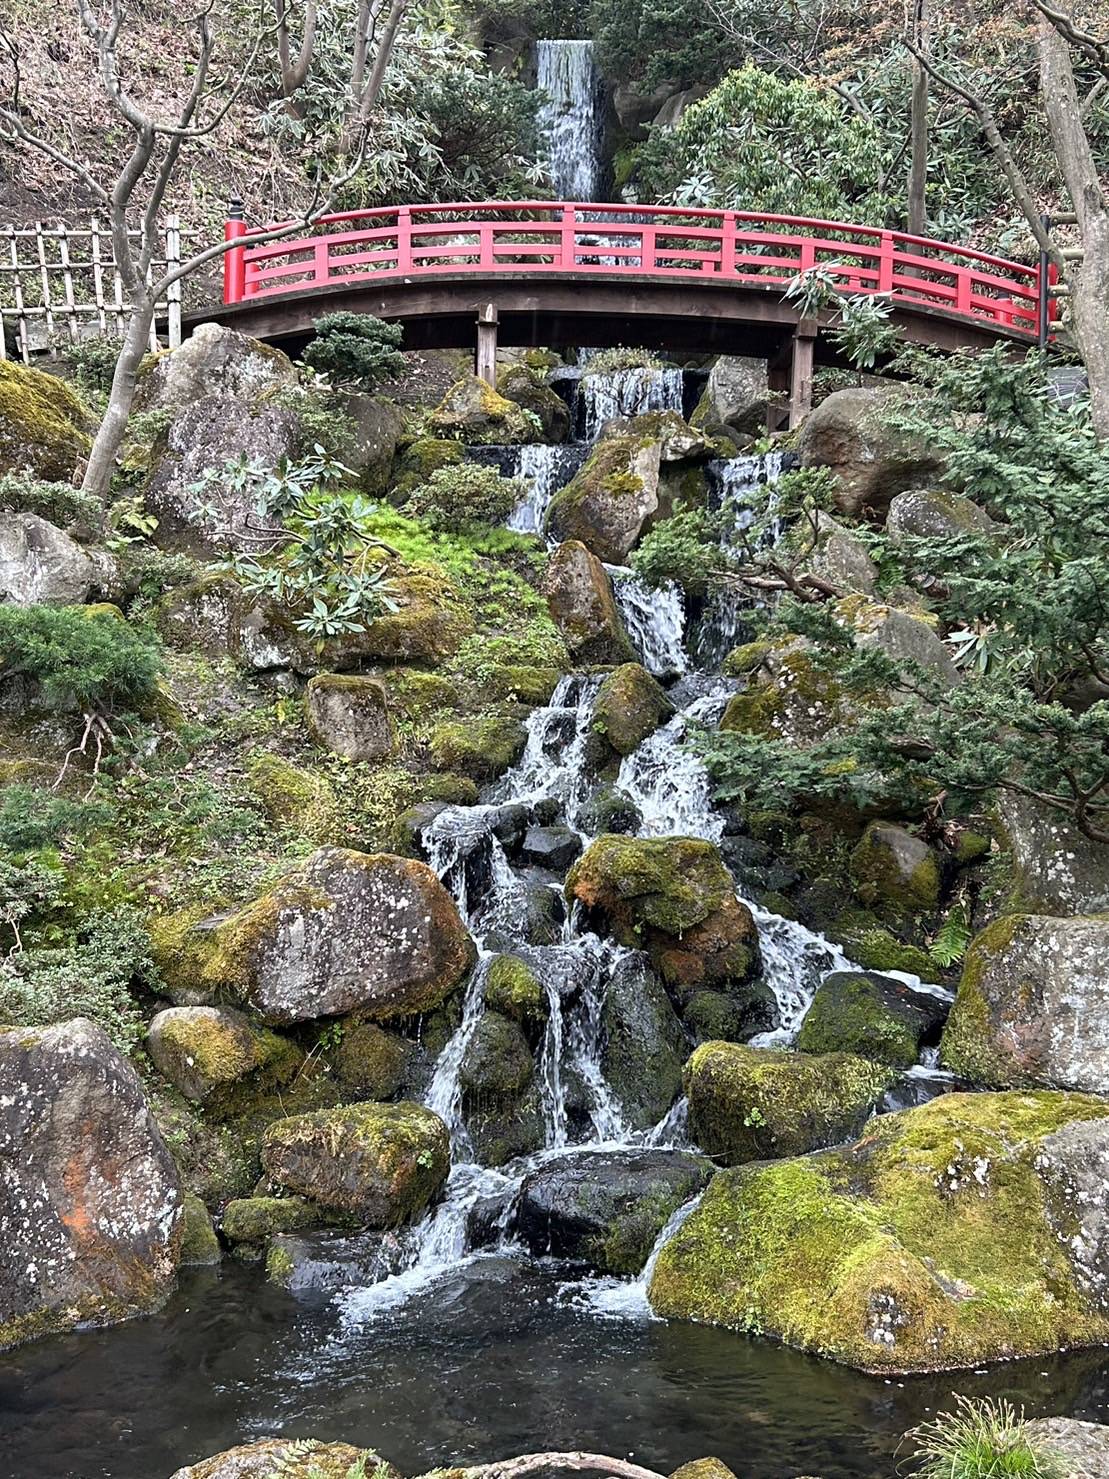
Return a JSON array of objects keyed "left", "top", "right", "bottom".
[{"left": 797, "top": 970, "right": 946, "bottom": 1068}]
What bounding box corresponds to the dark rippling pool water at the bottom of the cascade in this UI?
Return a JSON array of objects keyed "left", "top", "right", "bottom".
[{"left": 0, "top": 1259, "right": 1109, "bottom": 1479}]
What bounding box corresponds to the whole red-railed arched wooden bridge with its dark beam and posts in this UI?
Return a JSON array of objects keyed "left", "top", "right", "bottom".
[{"left": 191, "top": 201, "right": 1053, "bottom": 420}]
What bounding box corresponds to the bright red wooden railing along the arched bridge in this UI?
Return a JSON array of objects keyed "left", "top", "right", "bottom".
[{"left": 225, "top": 201, "right": 1041, "bottom": 337}]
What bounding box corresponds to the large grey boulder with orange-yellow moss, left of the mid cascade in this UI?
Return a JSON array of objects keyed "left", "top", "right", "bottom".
[{"left": 182, "top": 847, "right": 475, "bottom": 1023}]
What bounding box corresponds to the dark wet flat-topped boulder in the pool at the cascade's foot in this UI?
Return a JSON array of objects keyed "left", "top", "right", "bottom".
[{"left": 516, "top": 1151, "right": 713, "bottom": 1275}]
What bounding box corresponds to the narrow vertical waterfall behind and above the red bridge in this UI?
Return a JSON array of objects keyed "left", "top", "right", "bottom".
[{"left": 537, "top": 41, "right": 603, "bottom": 200}]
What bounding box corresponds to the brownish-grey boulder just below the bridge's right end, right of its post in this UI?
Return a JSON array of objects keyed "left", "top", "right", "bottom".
[{"left": 797, "top": 386, "right": 940, "bottom": 516}]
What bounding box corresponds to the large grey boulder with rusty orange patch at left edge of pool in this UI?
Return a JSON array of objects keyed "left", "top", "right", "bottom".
[{"left": 0, "top": 1018, "right": 182, "bottom": 1349}]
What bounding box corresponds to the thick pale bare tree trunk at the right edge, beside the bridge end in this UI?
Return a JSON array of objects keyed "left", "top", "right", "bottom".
[{"left": 1040, "top": 16, "right": 1109, "bottom": 436}]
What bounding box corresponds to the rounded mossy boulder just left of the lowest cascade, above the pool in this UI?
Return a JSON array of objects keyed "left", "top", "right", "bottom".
[{"left": 262, "top": 1102, "right": 451, "bottom": 1228}]
